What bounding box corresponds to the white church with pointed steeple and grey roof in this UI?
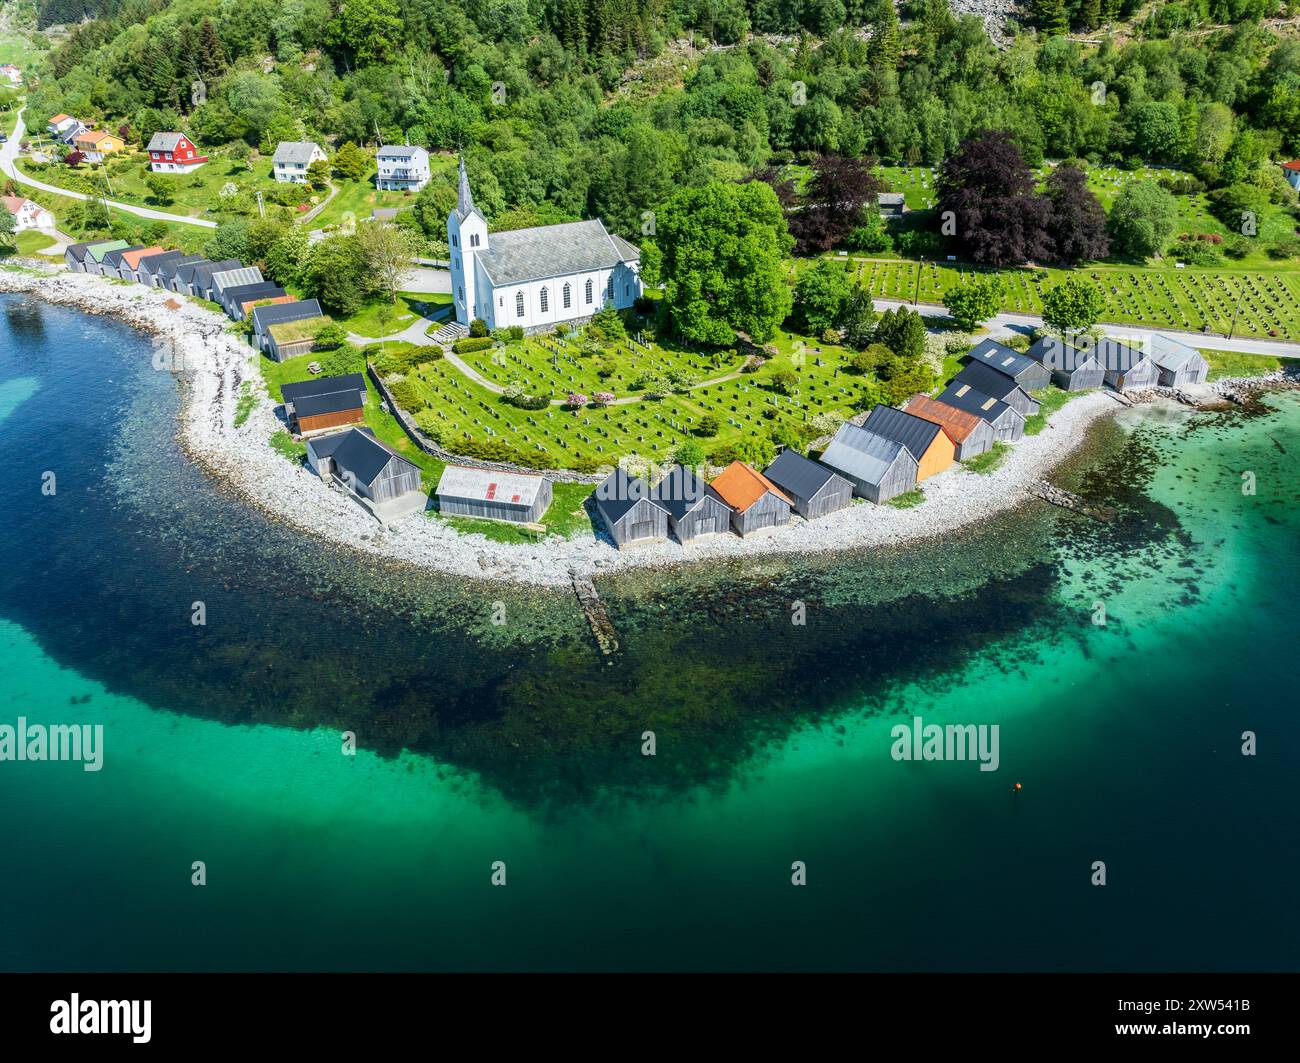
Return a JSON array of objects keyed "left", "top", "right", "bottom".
[{"left": 447, "top": 159, "right": 641, "bottom": 331}]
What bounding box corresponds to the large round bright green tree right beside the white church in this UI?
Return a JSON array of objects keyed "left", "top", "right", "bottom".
[{"left": 641, "top": 181, "right": 793, "bottom": 347}]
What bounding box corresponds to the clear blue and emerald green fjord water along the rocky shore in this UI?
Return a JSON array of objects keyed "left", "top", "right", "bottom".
[{"left": 0, "top": 289, "right": 1300, "bottom": 969}]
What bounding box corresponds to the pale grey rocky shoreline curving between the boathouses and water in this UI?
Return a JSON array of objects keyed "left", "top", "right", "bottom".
[{"left": 0, "top": 259, "right": 1290, "bottom": 587}]
